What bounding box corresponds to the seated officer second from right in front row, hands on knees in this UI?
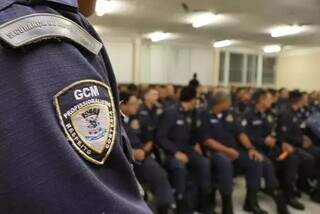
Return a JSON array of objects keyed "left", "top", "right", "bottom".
[{"left": 242, "top": 89, "right": 304, "bottom": 213}]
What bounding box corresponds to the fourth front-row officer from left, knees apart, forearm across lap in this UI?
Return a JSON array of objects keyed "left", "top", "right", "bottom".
[{"left": 201, "top": 92, "right": 267, "bottom": 214}]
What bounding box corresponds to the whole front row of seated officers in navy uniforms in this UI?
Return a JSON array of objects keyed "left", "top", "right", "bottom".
[{"left": 120, "top": 86, "right": 320, "bottom": 214}]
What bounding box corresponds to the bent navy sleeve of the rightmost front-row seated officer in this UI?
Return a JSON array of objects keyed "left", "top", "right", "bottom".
[{"left": 277, "top": 114, "right": 303, "bottom": 147}]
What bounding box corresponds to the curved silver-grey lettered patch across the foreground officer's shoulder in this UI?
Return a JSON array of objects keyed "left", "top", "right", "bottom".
[{"left": 0, "top": 13, "right": 102, "bottom": 55}]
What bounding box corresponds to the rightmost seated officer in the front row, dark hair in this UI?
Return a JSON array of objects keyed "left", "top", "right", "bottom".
[{"left": 277, "top": 90, "right": 320, "bottom": 203}]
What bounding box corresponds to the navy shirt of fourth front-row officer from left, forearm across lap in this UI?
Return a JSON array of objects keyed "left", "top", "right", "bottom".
[{"left": 201, "top": 112, "right": 243, "bottom": 149}]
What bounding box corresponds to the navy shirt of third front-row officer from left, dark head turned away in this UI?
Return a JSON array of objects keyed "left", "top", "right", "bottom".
[{"left": 157, "top": 104, "right": 193, "bottom": 155}]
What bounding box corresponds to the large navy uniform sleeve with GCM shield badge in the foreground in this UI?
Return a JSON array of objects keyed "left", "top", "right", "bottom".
[{"left": 0, "top": 0, "right": 151, "bottom": 214}]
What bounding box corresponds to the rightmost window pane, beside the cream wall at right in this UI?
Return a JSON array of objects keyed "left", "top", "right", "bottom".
[{"left": 262, "top": 56, "right": 276, "bottom": 85}]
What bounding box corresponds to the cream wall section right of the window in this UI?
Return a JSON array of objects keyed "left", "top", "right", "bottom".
[{"left": 276, "top": 50, "right": 320, "bottom": 91}]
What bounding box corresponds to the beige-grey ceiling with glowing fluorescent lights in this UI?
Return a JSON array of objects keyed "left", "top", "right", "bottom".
[{"left": 90, "top": 0, "right": 320, "bottom": 46}]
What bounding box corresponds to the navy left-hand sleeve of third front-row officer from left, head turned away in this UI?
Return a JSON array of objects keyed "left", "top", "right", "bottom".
[{"left": 156, "top": 111, "right": 178, "bottom": 155}]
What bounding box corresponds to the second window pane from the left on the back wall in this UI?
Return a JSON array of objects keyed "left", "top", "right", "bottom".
[{"left": 229, "top": 53, "right": 243, "bottom": 83}]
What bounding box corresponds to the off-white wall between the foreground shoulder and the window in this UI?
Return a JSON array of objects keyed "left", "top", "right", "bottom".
[{"left": 102, "top": 36, "right": 214, "bottom": 85}]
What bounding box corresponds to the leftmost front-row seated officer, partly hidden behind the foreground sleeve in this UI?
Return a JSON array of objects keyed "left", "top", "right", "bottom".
[{"left": 120, "top": 92, "right": 174, "bottom": 214}]
